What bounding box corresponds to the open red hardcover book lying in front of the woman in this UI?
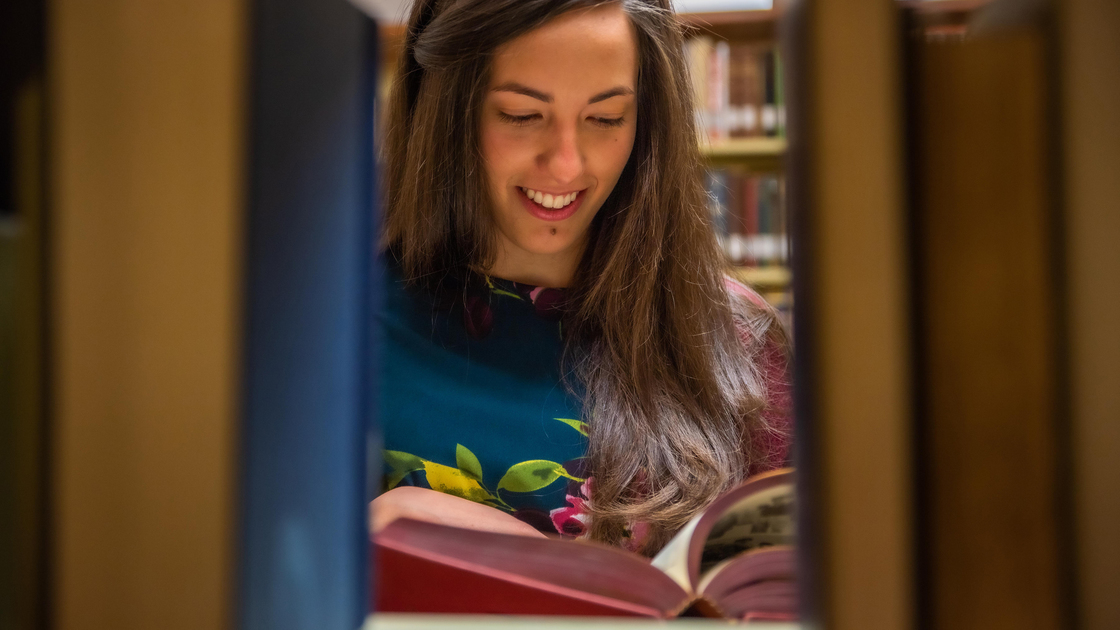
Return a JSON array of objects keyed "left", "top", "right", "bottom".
[{"left": 373, "top": 469, "right": 797, "bottom": 620}]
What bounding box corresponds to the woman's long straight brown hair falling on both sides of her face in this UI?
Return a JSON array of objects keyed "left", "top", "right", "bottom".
[{"left": 382, "top": 0, "right": 784, "bottom": 553}]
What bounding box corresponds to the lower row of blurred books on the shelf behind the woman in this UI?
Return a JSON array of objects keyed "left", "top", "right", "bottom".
[{"left": 708, "top": 168, "right": 790, "bottom": 267}]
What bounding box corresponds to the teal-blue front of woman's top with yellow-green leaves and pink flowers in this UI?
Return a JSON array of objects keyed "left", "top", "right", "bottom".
[{"left": 376, "top": 261, "right": 587, "bottom": 536}]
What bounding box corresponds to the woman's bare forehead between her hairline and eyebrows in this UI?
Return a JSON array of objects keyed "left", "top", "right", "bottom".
[{"left": 491, "top": 2, "right": 637, "bottom": 92}]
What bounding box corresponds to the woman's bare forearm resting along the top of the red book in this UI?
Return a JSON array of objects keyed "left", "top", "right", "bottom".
[{"left": 370, "top": 485, "right": 545, "bottom": 538}]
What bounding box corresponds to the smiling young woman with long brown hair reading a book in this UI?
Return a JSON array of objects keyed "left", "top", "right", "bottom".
[{"left": 372, "top": 0, "right": 790, "bottom": 554}]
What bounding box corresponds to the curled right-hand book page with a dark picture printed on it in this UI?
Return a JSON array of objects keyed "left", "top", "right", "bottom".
[{"left": 694, "top": 477, "right": 794, "bottom": 574}]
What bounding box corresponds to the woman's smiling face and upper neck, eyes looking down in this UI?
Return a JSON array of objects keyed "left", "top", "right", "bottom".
[{"left": 480, "top": 3, "right": 637, "bottom": 286}]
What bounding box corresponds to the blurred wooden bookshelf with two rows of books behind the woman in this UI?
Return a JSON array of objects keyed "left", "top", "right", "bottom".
[{"left": 680, "top": 8, "right": 793, "bottom": 309}]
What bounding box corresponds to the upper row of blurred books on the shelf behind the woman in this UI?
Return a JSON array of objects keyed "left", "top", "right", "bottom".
[{"left": 684, "top": 35, "right": 785, "bottom": 142}]
